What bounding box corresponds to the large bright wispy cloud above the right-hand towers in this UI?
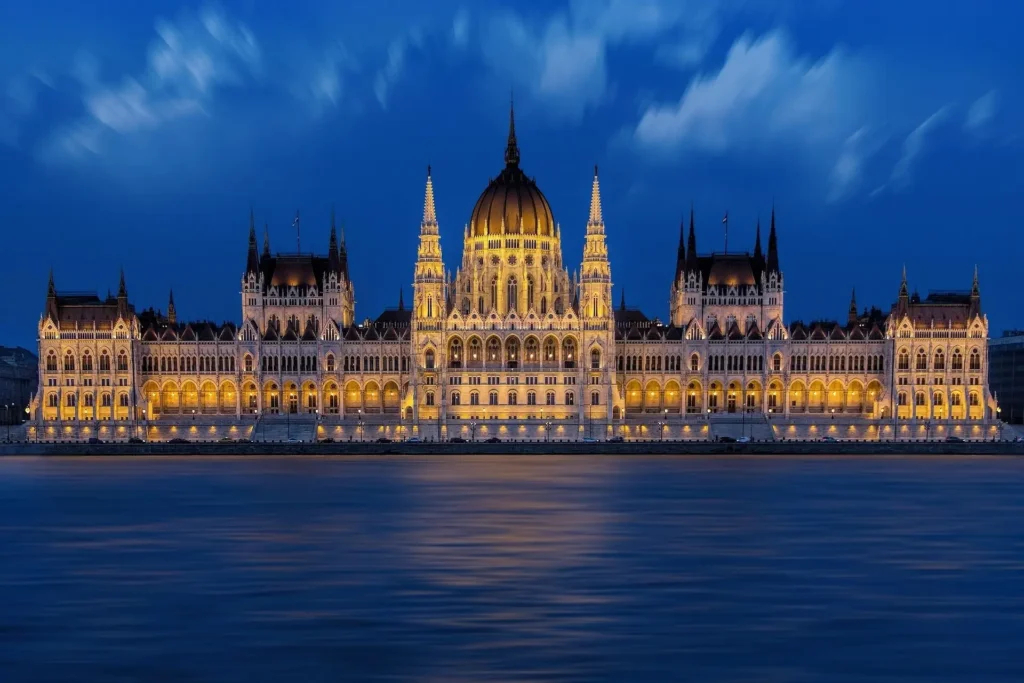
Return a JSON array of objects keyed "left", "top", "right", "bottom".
[{"left": 633, "top": 31, "right": 869, "bottom": 154}]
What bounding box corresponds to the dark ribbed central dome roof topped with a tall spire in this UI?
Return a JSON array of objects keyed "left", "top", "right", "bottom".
[{"left": 469, "top": 104, "right": 555, "bottom": 237}]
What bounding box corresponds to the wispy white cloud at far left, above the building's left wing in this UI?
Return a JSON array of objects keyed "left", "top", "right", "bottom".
[{"left": 43, "top": 8, "right": 260, "bottom": 160}]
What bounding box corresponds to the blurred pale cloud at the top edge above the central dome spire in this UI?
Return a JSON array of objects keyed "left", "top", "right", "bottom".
[{"left": 480, "top": 0, "right": 731, "bottom": 119}]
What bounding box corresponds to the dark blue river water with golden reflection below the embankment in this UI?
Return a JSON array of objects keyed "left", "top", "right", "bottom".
[{"left": 0, "top": 457, "right": 1024, "bottom": 681}]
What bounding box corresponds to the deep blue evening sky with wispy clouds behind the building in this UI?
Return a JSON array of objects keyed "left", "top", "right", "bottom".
[{"left": 0, "top": 0, "right": 1024, "bottom": 347}]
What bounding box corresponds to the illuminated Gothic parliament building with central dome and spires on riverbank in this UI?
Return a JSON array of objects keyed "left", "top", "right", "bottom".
[{"left": 30, "top": 107, "right": 997, "bottom": 440}]
